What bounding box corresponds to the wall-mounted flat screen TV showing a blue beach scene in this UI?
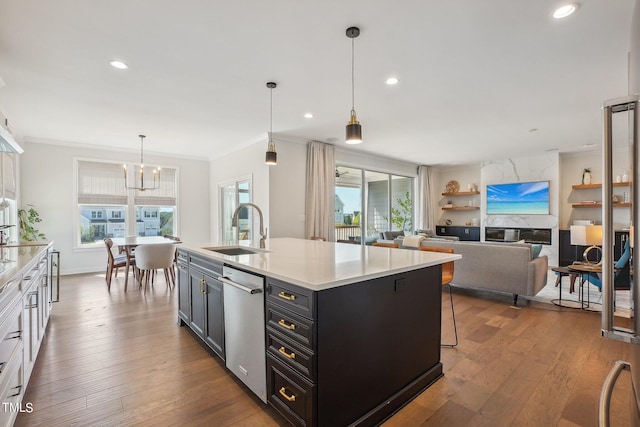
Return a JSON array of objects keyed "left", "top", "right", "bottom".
[{"left": 487, "top": 181, "right": 549, "bottom": 215}]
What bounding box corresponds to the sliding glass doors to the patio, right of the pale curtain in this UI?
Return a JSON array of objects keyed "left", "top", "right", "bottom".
[{"left": 334, "top": 166, "right": 413, "bottom": 243}]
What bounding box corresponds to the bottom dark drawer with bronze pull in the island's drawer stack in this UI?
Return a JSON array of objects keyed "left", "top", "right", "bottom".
[{"left": 267, "top": 354, "right": 316, "bottom": 426}]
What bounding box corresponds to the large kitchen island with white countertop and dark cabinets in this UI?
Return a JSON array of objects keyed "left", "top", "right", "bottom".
[{"left": 178, "top": 238, "right": 460, "bottom": 426}]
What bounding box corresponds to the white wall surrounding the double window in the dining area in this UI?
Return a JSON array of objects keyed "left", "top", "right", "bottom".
[{"left": 19, "top": 142, "right": 210, "bottom": 274}]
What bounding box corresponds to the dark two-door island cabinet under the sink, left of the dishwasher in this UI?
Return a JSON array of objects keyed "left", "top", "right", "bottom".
[{"left": 178, "top": 250, "right": 225, "bottom": 360}]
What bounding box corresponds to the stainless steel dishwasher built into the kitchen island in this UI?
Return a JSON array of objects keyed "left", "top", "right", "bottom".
[{"left": 218, "top": 265, "right": 267, "bottom": 403}]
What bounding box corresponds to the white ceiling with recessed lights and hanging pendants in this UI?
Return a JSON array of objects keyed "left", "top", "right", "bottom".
[{"left": 0, "top": 0, "right": 634, "bottom": 165}]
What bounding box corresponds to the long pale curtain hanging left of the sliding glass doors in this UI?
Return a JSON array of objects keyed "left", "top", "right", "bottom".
[{"left": 305, "top": 141, "right": 336, "bottom": 241}]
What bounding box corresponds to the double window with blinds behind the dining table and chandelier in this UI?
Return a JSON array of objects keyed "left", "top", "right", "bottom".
[{"left": 76, "top": 160, "right": 177, "bottom": 247}]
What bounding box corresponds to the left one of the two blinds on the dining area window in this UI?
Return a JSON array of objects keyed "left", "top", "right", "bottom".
[{"left": 78, "top": 160, "right": 127, "bottom": 205}]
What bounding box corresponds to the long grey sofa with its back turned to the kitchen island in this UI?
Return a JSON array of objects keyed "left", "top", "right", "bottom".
[{"left": 396, "top": 239, "right": 549, "bottom": 305}]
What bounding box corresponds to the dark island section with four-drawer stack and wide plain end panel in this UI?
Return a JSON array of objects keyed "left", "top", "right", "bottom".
[{"left": 266, "top": 265, "right": 442, "bottom": 426}]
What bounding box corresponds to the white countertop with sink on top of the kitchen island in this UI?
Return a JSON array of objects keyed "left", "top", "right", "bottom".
[{"left": 179, "top": 238, "right": 462, "bottom": 291}]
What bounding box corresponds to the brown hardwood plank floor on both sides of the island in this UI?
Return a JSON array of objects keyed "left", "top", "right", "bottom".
[{"left": 16, "top": 274, "right": 631, "bottom": 427}]
